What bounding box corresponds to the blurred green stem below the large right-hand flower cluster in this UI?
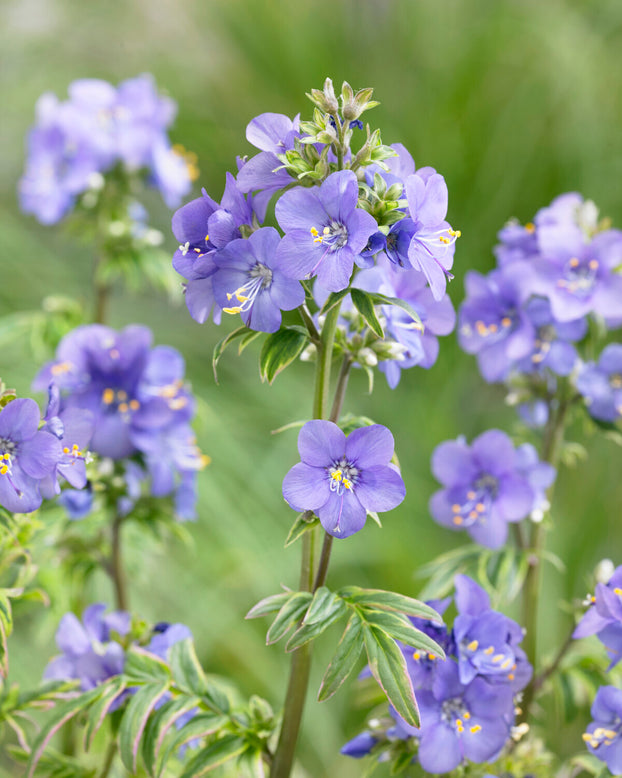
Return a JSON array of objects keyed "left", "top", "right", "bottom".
[{"left": 521, "top": 399, "right": 570, "bottom": 721}]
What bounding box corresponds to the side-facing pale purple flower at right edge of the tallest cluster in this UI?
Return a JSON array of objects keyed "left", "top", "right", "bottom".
[{"left": 406, "top": 168, "right": 460, "bottom": 300}]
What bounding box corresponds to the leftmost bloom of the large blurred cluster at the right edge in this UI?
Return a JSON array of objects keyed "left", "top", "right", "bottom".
[{"left": 458, "top": 263, "right": 536, "bottom": 381}]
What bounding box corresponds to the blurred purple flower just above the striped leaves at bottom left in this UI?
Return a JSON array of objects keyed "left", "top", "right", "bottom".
[{"left": 43, "top": 603, "right": 130, "bottom": 691}]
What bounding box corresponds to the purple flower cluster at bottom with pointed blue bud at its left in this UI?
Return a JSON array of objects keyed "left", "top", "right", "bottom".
[{"left": 342, "top": 575, "right": 532, "bottom": 775}]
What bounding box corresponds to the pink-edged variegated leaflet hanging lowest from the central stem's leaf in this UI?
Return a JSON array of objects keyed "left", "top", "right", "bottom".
[{"left": 363, "top": 624, "right": 419, "bottom": 727}]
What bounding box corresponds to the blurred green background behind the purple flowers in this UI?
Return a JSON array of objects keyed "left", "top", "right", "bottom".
[{"left": 0, "top": 0, "right": 622, "bottom": 777}]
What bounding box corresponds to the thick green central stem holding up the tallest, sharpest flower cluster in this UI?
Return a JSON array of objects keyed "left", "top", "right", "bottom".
[{"left": 270, "top": 305, "right": 347, "bottom": 778}]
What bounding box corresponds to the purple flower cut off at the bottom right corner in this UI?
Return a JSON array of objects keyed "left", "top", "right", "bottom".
[{"left": 583, "top": 686, "right": 622, "bottom": 775}]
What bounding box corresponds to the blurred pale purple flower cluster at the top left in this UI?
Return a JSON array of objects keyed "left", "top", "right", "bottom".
[{"left": 19, "top": 74, "right": 197, "bottom": 224}]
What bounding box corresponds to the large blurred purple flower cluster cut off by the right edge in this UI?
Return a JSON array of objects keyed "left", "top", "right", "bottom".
[{"left": 458, "top": 192, "right": 622, "bottom": 421}]
